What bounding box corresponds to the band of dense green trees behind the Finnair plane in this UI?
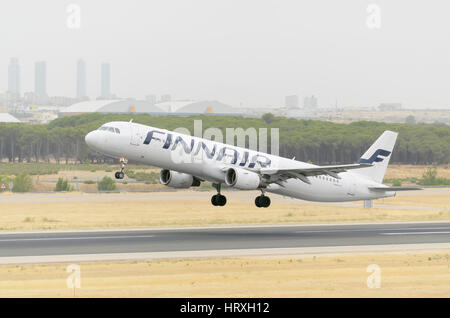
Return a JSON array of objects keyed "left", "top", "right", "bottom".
[{"left": 0, "top": 113, "right": 450, "bottom": 164}]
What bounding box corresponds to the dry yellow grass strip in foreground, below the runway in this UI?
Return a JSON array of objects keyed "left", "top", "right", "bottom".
[{"left": 0, "top": 252, "right": 450, "bottom": 297}]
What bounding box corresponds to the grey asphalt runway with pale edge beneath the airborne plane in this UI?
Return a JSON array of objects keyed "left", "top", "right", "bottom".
[{"left": 0, "top": 222, "right": 450, "bottom": 264}]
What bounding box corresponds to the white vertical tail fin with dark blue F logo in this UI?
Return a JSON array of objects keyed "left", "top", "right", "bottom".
[{"left": 355, "top": 130, "right": 398, "bottom": 183}]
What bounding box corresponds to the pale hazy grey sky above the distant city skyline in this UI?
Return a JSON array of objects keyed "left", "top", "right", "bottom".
[{"left": 0, "top": 0, "right": 450, "bottom": 109}]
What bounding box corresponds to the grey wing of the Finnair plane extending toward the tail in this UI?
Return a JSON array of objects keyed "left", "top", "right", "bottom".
[{"left": 259, "top": 163, "right": 372, "bottom": 184}]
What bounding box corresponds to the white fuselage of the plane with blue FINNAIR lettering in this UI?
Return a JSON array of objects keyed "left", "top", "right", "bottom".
[{"left": 86, "top": 122, "right": 395, "bottom": 202}]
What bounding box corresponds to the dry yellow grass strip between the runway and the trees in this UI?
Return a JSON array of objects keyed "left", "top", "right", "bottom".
[{"left": 0, "top": 189, "right": 450, "bottom": 230}]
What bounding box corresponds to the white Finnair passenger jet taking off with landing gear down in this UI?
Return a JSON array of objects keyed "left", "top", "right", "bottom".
[{"left": 85, "top": 121, "right": 420, "bottom": 208}]
